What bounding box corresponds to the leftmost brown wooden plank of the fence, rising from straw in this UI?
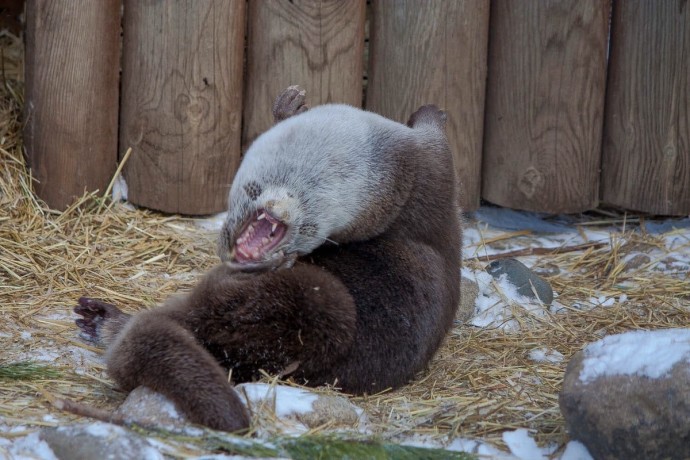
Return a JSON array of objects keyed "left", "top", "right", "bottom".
[{"left": 24, "top": 0, "right": 120, "bottom": 209}]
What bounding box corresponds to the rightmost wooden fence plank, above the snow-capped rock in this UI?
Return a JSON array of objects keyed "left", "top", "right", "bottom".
[{"left": 601, "top": 0, "right": 690, "bottom": 215}]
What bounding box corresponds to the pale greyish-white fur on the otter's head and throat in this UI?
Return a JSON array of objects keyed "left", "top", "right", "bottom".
[{"left": 226, "top": 104, "right": 411, "bottom": 254}]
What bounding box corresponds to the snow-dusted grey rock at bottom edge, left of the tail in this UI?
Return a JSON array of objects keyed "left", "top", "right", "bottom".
[{"left": 39, "top": 422, "right": 164, "bottom": 460}]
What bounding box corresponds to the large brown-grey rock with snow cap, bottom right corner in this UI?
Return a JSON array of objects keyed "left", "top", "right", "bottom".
[{"left": 559, "top": 329, "right": 690, "bottom": 459}]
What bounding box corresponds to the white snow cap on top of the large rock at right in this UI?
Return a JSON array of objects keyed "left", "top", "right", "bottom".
[{"left": 580, "top": 329, "right": 690, "bottom": 383}]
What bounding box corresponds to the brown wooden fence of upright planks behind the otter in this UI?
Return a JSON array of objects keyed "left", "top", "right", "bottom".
[{"left": 25, "top": 0, "right": 690, "bottom": 215}]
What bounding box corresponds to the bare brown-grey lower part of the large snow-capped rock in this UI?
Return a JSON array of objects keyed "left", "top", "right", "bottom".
[{"left": 559, "top": 344, "right": 690, "bottom": 459}]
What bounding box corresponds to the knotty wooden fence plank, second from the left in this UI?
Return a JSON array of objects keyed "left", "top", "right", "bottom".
[{"left": 120, "top": 0, "right": 245, "bottom": 215}]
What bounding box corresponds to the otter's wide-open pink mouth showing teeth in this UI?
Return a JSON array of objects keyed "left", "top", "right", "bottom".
[{"left": 235, "top": 209, "right": 287, "bottom": 263}]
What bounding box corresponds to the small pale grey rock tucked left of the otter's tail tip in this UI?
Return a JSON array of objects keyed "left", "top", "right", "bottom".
[{"left": 114, "top": 386, "right": 187, "bottom": 429}]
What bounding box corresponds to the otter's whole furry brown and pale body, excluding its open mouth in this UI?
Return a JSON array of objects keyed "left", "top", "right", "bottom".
[{"left": 75, "top": 88, "right": 460, "bottom": 431}]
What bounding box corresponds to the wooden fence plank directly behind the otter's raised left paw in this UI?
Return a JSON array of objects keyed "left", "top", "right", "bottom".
[{"left": 243, "top": 0, "right": 366, "bottom": 147}]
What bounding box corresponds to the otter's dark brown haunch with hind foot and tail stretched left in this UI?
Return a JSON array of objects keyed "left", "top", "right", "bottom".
[{"left": 75, "top": 264, "right": 356, "bottom": 431}]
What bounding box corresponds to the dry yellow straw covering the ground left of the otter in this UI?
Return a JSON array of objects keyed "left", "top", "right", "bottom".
[{"left": 0, "top": 34, "right": 215, "bottom": 438}]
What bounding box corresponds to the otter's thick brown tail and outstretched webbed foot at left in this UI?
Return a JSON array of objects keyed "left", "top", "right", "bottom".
[{"left": 74, "top": 297, "right": 249, "bottom": 432}]
